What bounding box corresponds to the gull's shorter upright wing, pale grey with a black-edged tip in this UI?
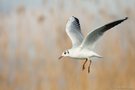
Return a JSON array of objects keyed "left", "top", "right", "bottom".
[{"left": 66, "top": 16, "right": 83, "bottom": 47}]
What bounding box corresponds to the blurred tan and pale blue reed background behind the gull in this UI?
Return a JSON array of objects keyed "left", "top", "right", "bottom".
[{"left": 0, "top": 0, "right": 135, "bottom": 90}]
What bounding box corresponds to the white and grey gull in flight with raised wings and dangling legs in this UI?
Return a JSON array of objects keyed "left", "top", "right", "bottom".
[{"left": 59, "top": 16, "right": 128, "bottom": 73}]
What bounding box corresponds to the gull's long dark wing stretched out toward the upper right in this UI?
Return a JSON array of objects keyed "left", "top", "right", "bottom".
[{"left": 81, "top": 17, "right": 128, "bottom": 49}]
